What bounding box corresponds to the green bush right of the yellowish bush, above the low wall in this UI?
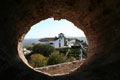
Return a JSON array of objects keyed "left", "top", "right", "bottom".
[{"left": 48, "top": 51, "right": 67, "bottom": 65}]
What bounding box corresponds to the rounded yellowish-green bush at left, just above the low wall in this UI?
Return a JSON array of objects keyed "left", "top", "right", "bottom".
[{"left": 30, "top": 54, "right": 47, "bottom": 68}]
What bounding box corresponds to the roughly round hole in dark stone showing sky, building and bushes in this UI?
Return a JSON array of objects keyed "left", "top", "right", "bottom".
[{"left": 23, "top": 18, "right": 88, "bottom": 75}]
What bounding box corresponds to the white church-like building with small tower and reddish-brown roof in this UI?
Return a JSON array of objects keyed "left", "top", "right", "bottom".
[{"left": 39, "top": 33, "right": 68, "bottom": 48}]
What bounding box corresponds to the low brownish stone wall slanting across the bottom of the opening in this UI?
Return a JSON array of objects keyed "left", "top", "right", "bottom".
[{"left": 35, "top": 60, "right": 84, "bottom": 76}]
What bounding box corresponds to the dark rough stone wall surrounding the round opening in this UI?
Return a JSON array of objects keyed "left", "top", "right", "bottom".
[{"left": 0, "top": 0, "right": 120, "bottom": 80}]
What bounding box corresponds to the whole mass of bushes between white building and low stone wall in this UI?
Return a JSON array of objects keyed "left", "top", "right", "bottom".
[{"left": 25, "top": 41, "right": 83, "bottom": 67}]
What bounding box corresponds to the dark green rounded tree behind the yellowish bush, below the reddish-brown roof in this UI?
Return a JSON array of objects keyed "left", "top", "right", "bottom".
[{"left": 32, "top": 44, "right": 55, "bottom": 57}]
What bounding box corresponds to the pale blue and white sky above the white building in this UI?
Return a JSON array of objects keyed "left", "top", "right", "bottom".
[{"left": 25, "top": 18, "right": 85, "bottom": 39}]
